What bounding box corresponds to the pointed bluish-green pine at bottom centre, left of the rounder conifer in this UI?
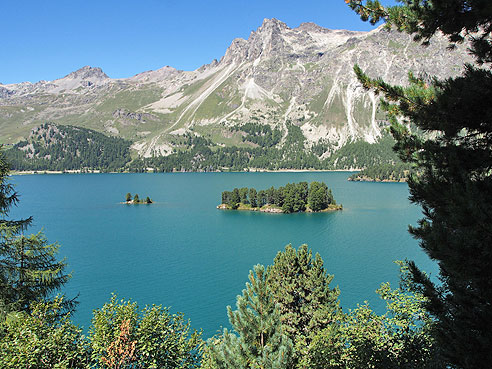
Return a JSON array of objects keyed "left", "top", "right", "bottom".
[{"left": 208, "top": 265, "right": 292, "bottom": 369}]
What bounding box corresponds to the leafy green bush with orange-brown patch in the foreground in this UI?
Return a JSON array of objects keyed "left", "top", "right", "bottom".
[{"left": 88, "top": 295, "right": 203, "bottom": 369}]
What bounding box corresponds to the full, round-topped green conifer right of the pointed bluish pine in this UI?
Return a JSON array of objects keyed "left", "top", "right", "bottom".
[{"left": 267, "top": 245, "right": 341, "bottom": 364}]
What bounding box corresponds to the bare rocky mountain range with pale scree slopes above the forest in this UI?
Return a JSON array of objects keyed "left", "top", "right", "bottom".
[{"left": 0, "top": 19, "right": 473, "bottom": 165}]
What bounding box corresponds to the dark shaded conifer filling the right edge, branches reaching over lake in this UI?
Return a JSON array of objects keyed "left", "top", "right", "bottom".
[{"left": 346, "top": 0, "right": 492, "bottom": 368}]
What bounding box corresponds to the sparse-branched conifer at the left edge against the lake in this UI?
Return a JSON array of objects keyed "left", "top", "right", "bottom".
[{"left": 0, "top": 152, "right": 74, "bottom": 320}]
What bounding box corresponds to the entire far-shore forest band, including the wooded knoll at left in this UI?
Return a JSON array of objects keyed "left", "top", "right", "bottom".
[{"left": 6, "top": 123, "right": 408, "bottom": 172}]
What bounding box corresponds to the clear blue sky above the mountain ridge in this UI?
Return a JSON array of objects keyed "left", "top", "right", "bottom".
[{"left": 0, "top": 0, "right": 393, "bottom": 84}]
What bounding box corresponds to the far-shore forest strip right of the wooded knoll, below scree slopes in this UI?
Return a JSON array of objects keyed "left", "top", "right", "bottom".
[{"left": 129, "top": 124, "right": 400, "bottom": 172}]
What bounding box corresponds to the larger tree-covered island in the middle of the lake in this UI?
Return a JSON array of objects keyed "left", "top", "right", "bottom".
[{"left": 217, "top": 182, "right": 343, "bottom": 213}]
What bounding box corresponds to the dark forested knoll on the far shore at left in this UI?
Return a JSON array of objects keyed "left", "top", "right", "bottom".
[{"left": 6, "top": 123, "right": 131, "bottom": 171}]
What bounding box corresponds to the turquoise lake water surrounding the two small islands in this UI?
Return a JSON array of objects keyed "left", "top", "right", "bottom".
[{"left": 11, "top": 172, "right": 436, "bottom": 337}]
